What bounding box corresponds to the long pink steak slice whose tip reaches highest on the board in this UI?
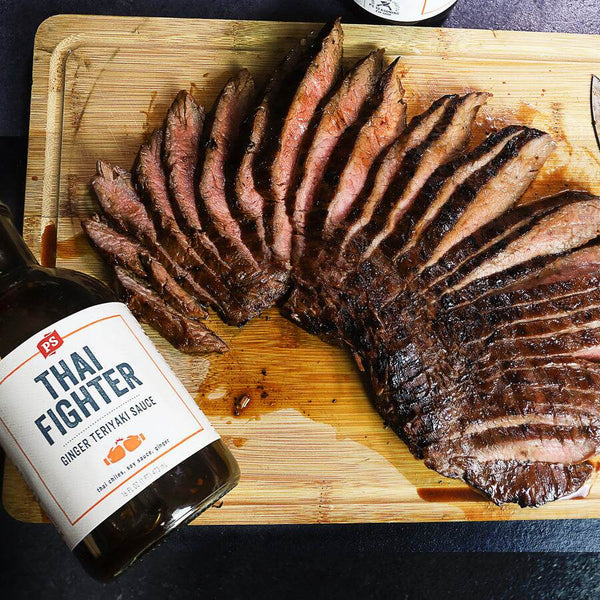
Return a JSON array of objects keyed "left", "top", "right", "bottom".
[{"left": 261, "top": 20, "right": 343, "bottom": 265}]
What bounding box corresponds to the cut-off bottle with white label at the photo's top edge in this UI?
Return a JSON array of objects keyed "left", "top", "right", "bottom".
[{"left": 353, "top": 0, "right": 457, "bottom": 26}]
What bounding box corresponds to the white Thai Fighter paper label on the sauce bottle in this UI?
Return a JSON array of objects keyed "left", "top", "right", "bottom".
[{"left": 0, "top": 302, "right": 219, "bottom": 549}]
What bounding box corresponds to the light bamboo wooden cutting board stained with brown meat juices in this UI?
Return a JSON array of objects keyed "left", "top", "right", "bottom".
[{"left": 8, "top": 11, "right": 600, "bottom": 524}]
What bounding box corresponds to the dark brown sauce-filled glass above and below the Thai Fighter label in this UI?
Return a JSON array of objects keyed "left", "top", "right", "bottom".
[{"left": 0, "top": 204, "right": 240, "bottom": 580}]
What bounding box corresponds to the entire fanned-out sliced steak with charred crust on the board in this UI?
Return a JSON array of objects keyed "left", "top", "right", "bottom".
[{"left": 83, "top": 21, "right": 600, "bottom": 506}]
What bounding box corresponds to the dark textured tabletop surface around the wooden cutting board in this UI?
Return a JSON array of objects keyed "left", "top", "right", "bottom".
[{"left": 0, "top": 0, "right": 600, "bottom": 600}]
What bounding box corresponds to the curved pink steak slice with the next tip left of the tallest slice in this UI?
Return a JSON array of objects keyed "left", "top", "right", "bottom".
[{"left": 198, "top": 69, "right": 258, "bottom": 272}]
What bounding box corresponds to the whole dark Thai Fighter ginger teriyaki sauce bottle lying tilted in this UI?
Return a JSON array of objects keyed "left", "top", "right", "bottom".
[{"left": 0, "top": 204, "right": 239, "bottom": 580}]
